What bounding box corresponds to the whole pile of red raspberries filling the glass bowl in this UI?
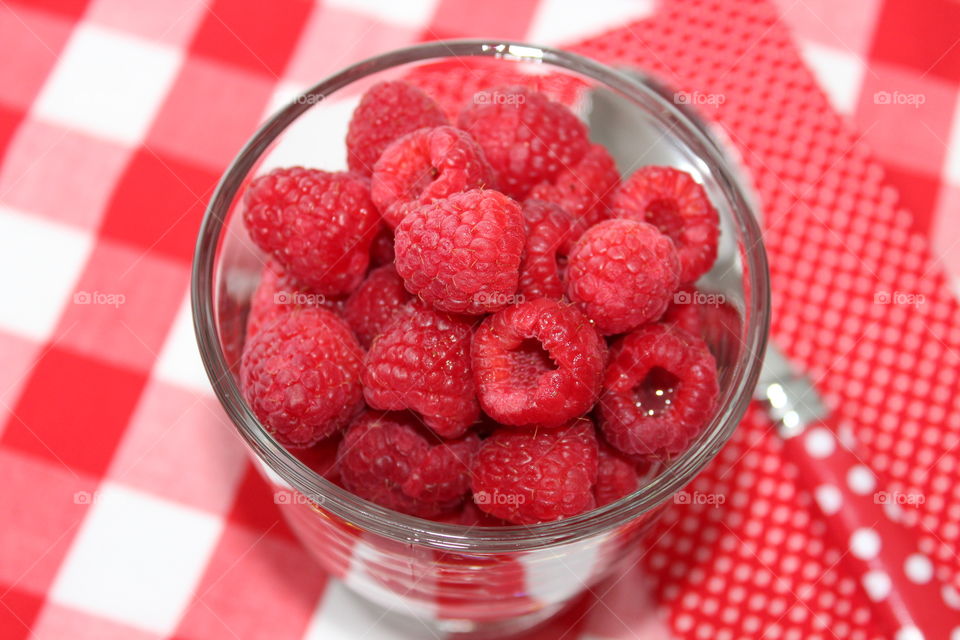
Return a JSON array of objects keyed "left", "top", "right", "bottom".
[{"left": 239, "top": 82, "right": 719, "bottom": 526}]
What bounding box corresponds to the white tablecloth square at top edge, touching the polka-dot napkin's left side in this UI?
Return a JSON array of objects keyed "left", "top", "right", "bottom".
[{"left": 526, "top": 0, "right": 656, "bottom": 44}]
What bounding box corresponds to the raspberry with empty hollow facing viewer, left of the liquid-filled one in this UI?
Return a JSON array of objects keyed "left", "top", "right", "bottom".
[{"left": 472, "top": 298, "right": 606, "bottom": 427}]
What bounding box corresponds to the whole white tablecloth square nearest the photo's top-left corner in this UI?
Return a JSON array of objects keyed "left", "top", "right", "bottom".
[{"left": 33, "top": 23, "right": 183, "bottom": 144}]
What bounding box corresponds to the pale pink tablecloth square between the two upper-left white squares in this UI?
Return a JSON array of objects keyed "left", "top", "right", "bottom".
[{"left": 0, "top": 119, "right": 131, "bottom": 230}]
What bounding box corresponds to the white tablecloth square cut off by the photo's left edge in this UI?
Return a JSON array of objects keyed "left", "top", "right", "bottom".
[{"left": 0, "top": 206, "right": 93, "bottom": 342}]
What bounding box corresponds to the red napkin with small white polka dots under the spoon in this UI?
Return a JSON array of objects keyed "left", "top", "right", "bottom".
[{"left": 528, "top": 0, "right": 960, "bottom": 640}]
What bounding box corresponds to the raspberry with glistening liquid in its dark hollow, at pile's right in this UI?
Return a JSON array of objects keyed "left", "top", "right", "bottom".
[{"left": 600, "top": 324, "right": 719, "bottom": 458}]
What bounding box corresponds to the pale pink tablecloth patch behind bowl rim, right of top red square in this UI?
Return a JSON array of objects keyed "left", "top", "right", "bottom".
[{"left": 284, "top": 6, "right": 418, "bottom": 84}]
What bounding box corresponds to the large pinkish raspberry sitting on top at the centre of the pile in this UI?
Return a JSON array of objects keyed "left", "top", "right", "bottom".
[{"left": 394, "top": 189, "right": 524, "bottom": 314}]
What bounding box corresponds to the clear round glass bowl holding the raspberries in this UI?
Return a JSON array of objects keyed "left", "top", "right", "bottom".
[{"left": 192, "top": 40, "right": 769, "bottom": 637}]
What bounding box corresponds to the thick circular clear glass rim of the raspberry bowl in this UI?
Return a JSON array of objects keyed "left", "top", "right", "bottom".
[{"left": 191, "top": 39, "right": 770, "bottom": 553}]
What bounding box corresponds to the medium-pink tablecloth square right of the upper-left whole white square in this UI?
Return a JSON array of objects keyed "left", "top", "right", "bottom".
[{"left": 147, "top": 57, "right": 274, "bottom": 172}]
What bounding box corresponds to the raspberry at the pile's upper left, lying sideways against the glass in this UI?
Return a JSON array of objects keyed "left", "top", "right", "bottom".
[{"left": 244, "top": 167, "right": 380, "bottom": 295}]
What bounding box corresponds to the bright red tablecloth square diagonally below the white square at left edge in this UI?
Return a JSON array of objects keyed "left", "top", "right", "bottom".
[{"left": 0, "top": 346, "right": 147, "bottom": 476}]
